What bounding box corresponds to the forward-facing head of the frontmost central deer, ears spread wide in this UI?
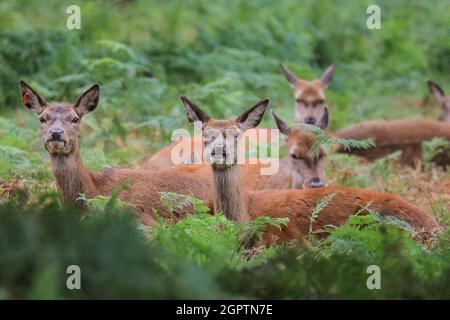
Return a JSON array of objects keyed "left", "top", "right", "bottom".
[{"left": 181, "top": 96, "right": 269, "bottom": 169}]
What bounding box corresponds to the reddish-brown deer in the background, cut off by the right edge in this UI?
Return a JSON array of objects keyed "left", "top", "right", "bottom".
[{"left": 336, "top": 80, "right": 450, "bottom": 166}]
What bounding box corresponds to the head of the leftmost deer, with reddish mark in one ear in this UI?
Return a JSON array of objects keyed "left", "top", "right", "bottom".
[{"left": 19, "top": 80, "right": 100, "bottom": 156}]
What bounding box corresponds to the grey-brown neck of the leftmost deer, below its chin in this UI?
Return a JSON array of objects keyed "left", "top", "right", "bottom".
[{"left": 50, "top": 148, "right": 95, "bottom": 204}]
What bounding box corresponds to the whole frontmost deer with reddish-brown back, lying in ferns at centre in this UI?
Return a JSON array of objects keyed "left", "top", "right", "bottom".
[{"left": 179, "top": 99, "right": 438, "bottom": 244}]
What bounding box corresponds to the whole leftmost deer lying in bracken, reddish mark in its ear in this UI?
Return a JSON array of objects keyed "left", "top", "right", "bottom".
[{"left": 20, "top": 81, "right": 218, "bottom": 224}]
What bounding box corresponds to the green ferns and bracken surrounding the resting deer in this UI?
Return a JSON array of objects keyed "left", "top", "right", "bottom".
[{"left": 0, "top": 0, "right": 450, "bottom": 299}]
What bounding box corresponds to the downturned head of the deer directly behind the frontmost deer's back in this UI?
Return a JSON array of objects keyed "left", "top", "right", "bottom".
[{"left": 272, "top": 111, "right": 326, "bottom": 189}]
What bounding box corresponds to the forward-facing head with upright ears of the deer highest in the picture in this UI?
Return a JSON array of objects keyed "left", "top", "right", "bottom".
[{"left": 280, "top": 64, "right": 335, "bottom": 129}]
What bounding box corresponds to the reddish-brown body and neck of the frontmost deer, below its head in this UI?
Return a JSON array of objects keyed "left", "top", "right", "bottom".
[{"left": 213, "top": 162, "right": 438, "bottom": 244}]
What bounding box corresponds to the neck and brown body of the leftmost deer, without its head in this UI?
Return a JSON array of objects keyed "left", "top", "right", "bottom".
[{"left": 51, "top": 150, "right": 213, "bottom": 224}]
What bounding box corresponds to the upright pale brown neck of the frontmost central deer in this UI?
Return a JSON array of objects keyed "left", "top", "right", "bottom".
[{"left": 212, "top": 165, "right": 250, "bottom": 223}]
